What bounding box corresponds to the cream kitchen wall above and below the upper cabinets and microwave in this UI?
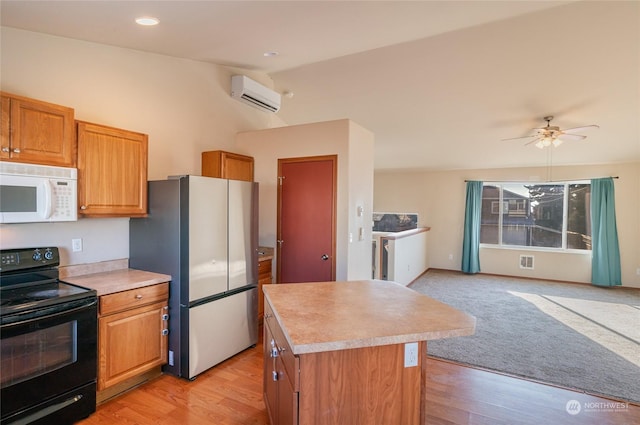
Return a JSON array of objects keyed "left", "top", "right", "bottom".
[{"left": 0, "top": 27, "right": 283, "bottom": 265}]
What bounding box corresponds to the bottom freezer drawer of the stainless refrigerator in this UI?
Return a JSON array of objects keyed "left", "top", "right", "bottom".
[{"left": 187, "top": 287, "right": 258, "bottom": 379}]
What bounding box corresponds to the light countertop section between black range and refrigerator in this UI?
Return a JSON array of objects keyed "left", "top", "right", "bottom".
[{"left": 62, "top": 269, "right": 171, "bottom": 296}]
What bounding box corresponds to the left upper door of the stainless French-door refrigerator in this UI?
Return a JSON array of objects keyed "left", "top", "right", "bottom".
[{"left": 189, "top": 176, "right": 228, "bottom": 301}]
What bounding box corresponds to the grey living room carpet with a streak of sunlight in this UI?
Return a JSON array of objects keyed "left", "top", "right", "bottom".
[{"left": 410, "top": 270, "right": 640, "bottom": 403}]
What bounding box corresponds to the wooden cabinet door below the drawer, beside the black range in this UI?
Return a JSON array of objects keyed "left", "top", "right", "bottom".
[{"left": 98, "top": 301, "right": 168, "bottom": 390}]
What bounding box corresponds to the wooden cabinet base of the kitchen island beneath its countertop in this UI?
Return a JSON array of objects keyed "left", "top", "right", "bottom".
[{"left": 263, "top": 299, "right": 427, "bottom": 425}]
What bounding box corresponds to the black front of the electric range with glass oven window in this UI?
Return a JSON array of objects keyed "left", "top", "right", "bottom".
[{"left": 0, "top": 297, "right": 97, "bottom": 424}]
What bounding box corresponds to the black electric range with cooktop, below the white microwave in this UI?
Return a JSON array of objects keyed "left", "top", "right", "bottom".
[{"left": 0, "top": 247, "right": 98, "bottom": 425}]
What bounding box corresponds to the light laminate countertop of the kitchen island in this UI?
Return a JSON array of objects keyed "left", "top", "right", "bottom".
[{"left": 263, "top": 280, "right": 476, "bottom": 355}]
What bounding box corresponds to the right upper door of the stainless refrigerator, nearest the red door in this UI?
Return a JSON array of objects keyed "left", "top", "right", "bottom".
[{"left": 229, "top": 180, "right": 256, "bottom": 289}]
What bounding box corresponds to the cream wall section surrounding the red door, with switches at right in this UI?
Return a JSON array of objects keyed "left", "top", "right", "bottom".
[{"left": 236, "top": 119, "right": 373, "bottom": 280}]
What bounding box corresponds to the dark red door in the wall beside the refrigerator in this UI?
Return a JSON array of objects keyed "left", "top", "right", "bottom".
[{"left": 276, "top": 155, "right": 337, "bottom": 283}]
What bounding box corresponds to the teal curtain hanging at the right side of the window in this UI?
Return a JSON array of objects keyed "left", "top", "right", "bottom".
[{"left": 591, "top": 177, "right": 622, "bottom": 286}]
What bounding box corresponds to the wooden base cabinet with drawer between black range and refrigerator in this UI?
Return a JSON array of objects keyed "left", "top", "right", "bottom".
[{"left": 98, "top": 283, "right": 169, "bottom": 392}]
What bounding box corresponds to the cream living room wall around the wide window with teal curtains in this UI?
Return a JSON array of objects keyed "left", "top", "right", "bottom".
[{"left": 374, "top": 162, "right": 640, "bottom": 287}]
